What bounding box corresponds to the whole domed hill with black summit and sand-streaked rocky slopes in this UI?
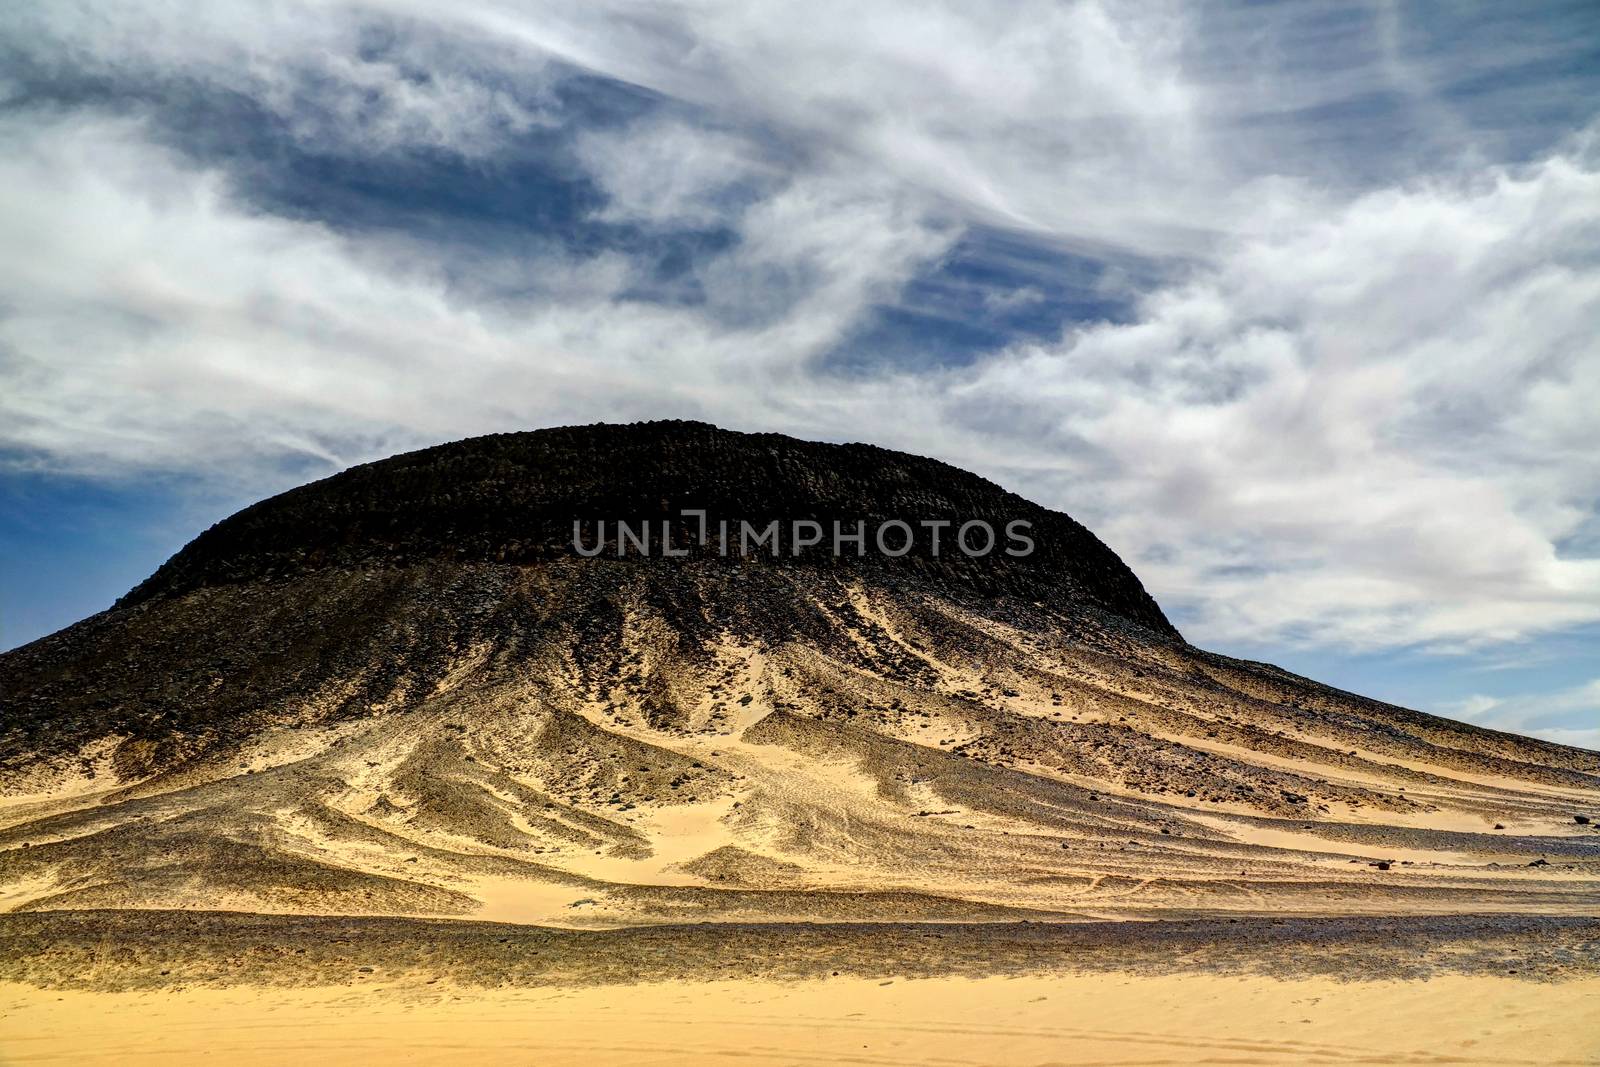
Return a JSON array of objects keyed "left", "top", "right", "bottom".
[{"left": 0, "top": 424, "right": 1600, "bottom": 926}]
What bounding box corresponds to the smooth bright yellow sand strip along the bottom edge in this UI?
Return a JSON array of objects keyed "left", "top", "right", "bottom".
[{"left": 0, "top": 974, "right": 1600, "bottom": 1067}]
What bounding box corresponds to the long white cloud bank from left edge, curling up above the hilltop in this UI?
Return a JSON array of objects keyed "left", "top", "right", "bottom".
[{"left": 0, "top": 103, "right": 946, "bottom": 480}]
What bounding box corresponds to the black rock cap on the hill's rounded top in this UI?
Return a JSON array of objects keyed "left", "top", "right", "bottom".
[{"left": 120, "top": 422, "right": 1178, "bottom": 638}]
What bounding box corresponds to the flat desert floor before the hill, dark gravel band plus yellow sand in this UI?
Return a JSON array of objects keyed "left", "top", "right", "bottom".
[{"left": 0, "top": 912, "right": 1600, "bottom": 1067}]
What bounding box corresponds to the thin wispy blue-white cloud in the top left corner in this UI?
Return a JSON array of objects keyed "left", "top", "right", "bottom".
[{"left": 0, "top": 0, "right": 557, "bottom": 157}]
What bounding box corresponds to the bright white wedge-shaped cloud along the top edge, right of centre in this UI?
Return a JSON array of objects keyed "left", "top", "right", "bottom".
[{"left": 422, "top": 0, "right": 1209, "bottom": 254}]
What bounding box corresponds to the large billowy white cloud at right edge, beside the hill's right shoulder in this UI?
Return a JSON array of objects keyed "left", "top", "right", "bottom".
[{"left": 950, "top": 147, "right": 1600, "bottom": 646}]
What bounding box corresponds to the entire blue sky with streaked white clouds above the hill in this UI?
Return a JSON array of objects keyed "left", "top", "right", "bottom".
[{"left": 0, "top": 0, "right": 1600, "bottom": 747}]
